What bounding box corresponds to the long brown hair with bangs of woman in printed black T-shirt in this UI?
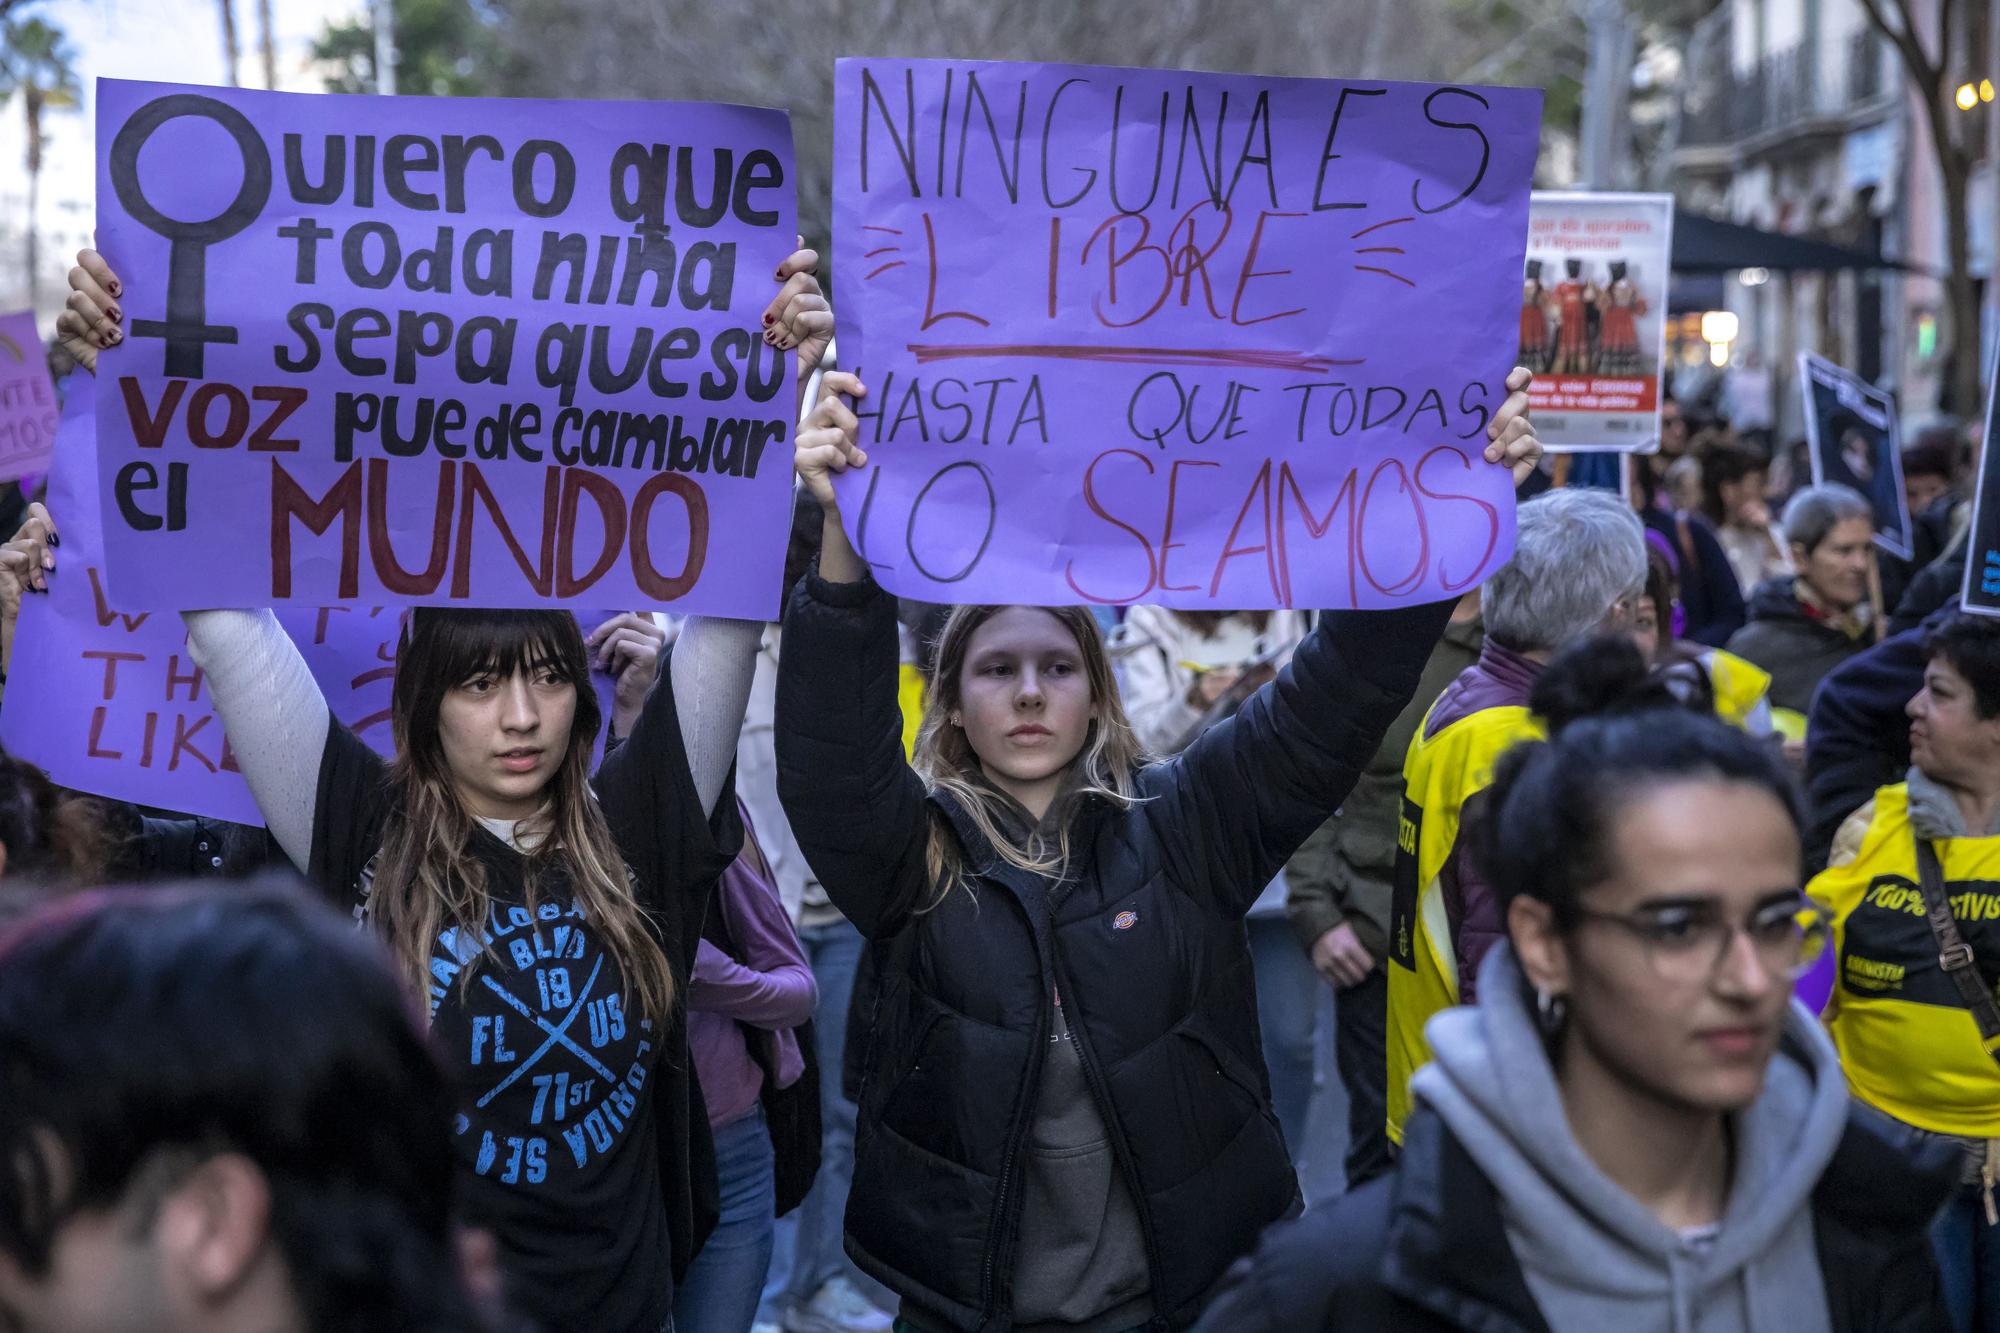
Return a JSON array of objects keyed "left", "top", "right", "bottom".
[{"left": 368, "top": 610, "right": 674, "bottom": 1019}]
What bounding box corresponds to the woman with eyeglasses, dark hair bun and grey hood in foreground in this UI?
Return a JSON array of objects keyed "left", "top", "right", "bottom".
[{"left": 1202, "top": 640, "right": 1952, "bottom": 1333}]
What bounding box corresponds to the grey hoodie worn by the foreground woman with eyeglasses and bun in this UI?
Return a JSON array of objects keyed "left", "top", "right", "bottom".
[{"left": 1410, "top": 943, "right": 1848, "bottom": 1333}]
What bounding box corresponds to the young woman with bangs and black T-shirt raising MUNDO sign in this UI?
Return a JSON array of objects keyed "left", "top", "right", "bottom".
[{"left": 60, "top": 241, "right": 832, "bottom": 1333}]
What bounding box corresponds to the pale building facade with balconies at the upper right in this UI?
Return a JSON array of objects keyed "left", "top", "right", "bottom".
[{"left": 1672, "top": 0, "right": 2000, "bottom": 438}]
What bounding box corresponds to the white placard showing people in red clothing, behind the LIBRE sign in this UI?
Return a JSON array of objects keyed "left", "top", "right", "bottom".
[{"left": 1520, "top": 192, "right": 1674, "bottom": 454}]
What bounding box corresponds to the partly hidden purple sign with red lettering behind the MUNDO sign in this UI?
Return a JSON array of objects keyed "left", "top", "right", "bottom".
[{"left": 0, "top": 384, "right": 612, "bottom": 825}]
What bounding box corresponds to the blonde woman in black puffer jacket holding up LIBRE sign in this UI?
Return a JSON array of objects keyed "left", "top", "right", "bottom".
[{"left": 776, "top": 370, "right": 1540, "bottom": 1333}]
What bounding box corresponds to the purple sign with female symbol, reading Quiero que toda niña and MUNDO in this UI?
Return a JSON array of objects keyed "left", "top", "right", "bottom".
[{"left": 98, "top": 80, "right": 796, "bottom": 618}]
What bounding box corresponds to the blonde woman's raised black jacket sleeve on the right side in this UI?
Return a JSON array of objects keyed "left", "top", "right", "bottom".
[{"left": 1138, "top": 602, "right": 1452, "bottom": 917}]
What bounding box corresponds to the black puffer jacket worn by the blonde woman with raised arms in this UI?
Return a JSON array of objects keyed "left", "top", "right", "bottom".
[{"left": 776, "top": 576, "right": 1450, "bottom": 1333}]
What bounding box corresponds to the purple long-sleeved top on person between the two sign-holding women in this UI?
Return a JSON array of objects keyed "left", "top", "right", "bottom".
[{"left": 688, "top": 811, "right": 820, "bottom": 1125}]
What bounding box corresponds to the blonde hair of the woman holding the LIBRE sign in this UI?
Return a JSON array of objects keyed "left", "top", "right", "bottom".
[{"left": 912, "top": 606, "right": 1146, "bottom": 907}]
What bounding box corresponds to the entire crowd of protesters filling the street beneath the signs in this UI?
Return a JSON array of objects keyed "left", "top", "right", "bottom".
[{"left": 0, "top": 244, "right": 2000, "bottom": 1333}]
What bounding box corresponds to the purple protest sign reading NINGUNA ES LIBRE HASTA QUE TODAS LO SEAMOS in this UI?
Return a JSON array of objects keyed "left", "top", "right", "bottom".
[{"left": 834, "top": 58, "right": 1542, "bottom": 608}]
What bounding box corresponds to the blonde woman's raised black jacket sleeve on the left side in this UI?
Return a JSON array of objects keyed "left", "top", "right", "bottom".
[{"left": 776, "top": 572, "right": 930, "bottom": 939}]
